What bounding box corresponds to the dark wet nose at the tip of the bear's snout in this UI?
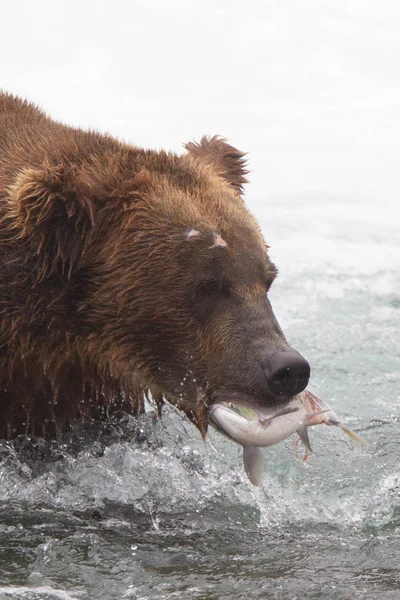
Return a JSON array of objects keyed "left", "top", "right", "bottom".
[{"left": 265, "top": 350, "right": 310, "bottom": 398}]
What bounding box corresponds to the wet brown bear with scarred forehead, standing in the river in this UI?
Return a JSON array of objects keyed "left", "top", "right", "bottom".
[{"left": 0, "top": 93, "right": 309, "bottom": 438}]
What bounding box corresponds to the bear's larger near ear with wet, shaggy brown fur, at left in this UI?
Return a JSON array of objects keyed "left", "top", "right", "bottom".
[{"left": 9, "top": 164, "right": 96, "bottom": 280}]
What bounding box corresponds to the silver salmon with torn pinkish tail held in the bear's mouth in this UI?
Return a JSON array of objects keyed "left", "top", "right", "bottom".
[{"left": 208, "top": 390, "right": 367, "bottom": 485}]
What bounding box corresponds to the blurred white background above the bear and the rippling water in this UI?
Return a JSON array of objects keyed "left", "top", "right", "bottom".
[{"left": 0, "top": 0, "right": 400, "bottom": 205}]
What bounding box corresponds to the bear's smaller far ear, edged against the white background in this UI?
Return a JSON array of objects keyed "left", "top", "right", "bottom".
[{"left": 185, "top": 135, "right": 249, "bottom": 194}]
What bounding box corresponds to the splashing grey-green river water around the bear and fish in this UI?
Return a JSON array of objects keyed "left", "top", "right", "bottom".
[{"left": 0, "top": 195, "right": 400, "bottom": 600}]
